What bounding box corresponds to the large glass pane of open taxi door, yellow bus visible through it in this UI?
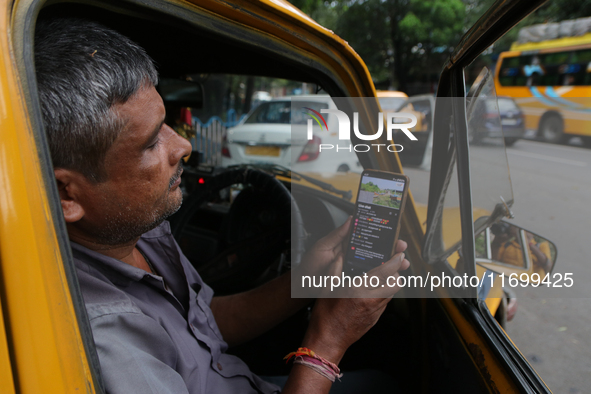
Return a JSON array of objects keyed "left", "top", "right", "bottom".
[{"left": 466, "top": 6, "right": 591, "bottom": 392}]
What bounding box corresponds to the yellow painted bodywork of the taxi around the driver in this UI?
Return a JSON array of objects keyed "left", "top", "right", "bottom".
[{"left": 0, "top": 0, "right": 552, "bottom": 394}]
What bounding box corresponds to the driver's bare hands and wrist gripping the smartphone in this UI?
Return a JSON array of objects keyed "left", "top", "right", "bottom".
[{"left": 283, "top": 218, "right": 410, "bottom": 394}]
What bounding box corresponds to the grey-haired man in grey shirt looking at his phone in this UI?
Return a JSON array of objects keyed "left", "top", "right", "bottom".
[{"left": 35, "top": 19, "right": 409, "bottom": 394}]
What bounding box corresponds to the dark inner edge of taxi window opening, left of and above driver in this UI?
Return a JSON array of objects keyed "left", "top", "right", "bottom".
[{"left": 11, "top": 0, "right": 374, "bottom": 394}]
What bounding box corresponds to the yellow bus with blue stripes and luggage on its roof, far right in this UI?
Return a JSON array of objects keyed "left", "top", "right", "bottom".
[{"left": 495, "top": 33, "right": 591, "bottom": 146}]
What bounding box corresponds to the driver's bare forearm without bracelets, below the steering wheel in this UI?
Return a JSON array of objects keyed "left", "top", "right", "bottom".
[{"left": 211, "top": 272, "right": 310, "bottom": 346}]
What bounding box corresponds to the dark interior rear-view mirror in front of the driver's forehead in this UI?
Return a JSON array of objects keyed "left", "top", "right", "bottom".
[{"left": 156, "top": 78, "right": 205, "bottom": 109}]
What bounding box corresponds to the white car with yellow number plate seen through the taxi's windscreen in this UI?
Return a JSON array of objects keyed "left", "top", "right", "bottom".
[{"left": 222, "top": 95, "right": 362, "bottom": 173}]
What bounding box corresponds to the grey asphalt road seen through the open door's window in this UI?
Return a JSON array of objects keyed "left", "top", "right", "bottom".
[{"left": 507, "top": 140, "right": 591, "bottom": 394}]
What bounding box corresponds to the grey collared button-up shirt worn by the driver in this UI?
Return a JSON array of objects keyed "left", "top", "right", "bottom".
[{"left": 72, "top": 222, "right": 279, "bottom": 394}]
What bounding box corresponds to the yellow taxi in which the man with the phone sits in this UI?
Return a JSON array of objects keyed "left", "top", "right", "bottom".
[{"left": 0, "top": 0, "right": 549, "bottom": 394}]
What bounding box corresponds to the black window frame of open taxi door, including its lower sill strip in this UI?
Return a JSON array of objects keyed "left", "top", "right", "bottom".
[{"left": 423, "top": 0, "right": 551, "bottom": 393}]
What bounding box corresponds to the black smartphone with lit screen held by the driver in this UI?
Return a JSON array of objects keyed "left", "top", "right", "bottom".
[{"left": 343, "top": 170, "right": 409, "bottom": 276}]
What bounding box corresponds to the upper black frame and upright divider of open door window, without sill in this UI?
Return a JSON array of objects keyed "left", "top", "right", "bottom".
[{"left": 423, "top": 0, "right": 544, "bottom": 284}]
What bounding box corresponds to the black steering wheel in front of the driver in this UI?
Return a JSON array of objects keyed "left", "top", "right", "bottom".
[{"left": 171, "top": 167, "right": 306, "bottom": 293}]
